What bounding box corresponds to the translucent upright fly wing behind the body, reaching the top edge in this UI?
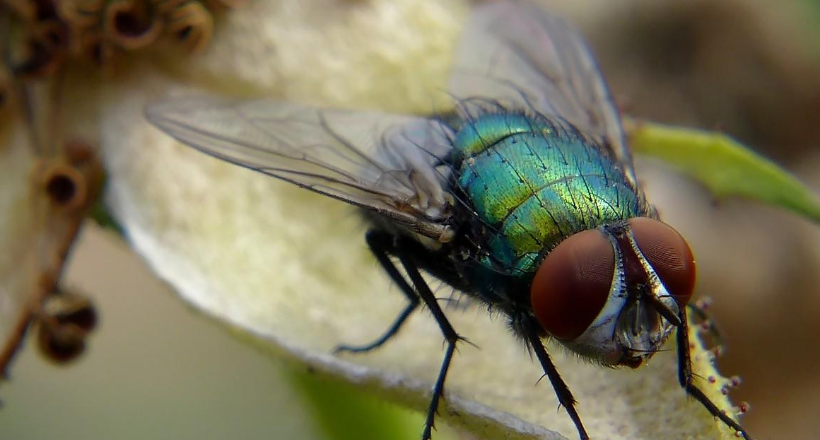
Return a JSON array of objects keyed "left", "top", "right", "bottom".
[{"left": 450, "top": 1, "right": 635, "bottom": 189}]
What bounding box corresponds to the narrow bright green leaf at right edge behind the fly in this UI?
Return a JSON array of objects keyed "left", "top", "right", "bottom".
[{"left": 624, "top": 121, "right": 820, "bottom": 223}]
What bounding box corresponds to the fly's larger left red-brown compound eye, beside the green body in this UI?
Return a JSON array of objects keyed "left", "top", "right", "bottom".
[{"left": 530, "top": 229, "right": 615, "bottom": 340}]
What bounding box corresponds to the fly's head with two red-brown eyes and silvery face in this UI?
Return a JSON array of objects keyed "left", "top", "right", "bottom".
[{"left": 530, "top": 217, "right": 695, "bottom": 368}]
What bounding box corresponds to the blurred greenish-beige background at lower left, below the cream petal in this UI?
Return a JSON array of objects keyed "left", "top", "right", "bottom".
[{"left": 0, "top": 225, "right": 346, "bottom": 440}]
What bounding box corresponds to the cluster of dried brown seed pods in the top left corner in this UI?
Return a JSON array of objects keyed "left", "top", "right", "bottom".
[{"left": 6, "top": 0, "right": 246, "bottom": 77}]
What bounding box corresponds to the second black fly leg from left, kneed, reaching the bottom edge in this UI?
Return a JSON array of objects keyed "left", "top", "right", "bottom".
[{"left": 395, "top": 239, "right": 463, "bottom": 440}]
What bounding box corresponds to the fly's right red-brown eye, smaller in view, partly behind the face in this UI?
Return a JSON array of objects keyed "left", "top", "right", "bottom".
[{"left": 629, "top": 217, "right": 696, "bottom": 305}]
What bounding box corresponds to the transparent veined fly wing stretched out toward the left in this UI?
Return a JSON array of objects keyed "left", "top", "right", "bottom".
[{"left": 146, "top": 97, "right": 452, "bottom": 239}]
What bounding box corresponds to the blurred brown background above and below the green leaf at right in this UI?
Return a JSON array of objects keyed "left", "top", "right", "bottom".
[{"left": 588, "top": 0, "right": 820, "bottom": 439}]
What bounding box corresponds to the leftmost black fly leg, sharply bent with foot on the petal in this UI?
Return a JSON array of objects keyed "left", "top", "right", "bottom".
[{"left": 334, "top": 230, "right": 419, "bottom": 353}]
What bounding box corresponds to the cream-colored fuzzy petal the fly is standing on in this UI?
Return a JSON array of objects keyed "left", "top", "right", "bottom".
[{"left": 101, "top": 0, "right": 734, "bottom": 439}]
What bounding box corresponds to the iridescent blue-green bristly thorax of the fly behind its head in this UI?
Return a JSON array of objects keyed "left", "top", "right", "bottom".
[{"left": 453, "top": 113, "right": 648, "bottom": 275}]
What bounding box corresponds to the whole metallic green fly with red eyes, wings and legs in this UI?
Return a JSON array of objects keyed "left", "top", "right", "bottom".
[{"left": 147, "top": 2, "right": 749, "bottom": 440}]
